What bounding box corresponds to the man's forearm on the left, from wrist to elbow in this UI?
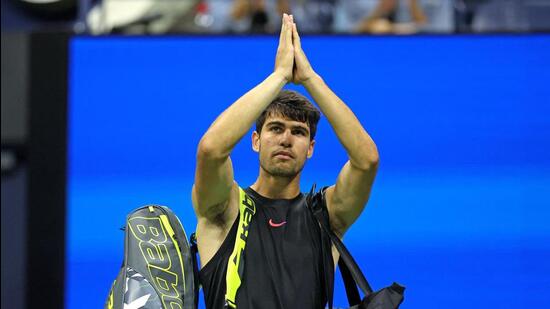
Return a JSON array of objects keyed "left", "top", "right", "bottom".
[{"left": 200, "top": 73, "right": 287, "bottom": 157}]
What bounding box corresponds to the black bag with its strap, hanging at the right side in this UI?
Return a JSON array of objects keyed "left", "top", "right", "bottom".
[{"left": 307, "top": 185, "right": 405, "bottom": 309}]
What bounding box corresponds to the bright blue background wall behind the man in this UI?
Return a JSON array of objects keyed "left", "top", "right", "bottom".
[{"left": 66, "top": 36, "right": 550, "bottom": 309}]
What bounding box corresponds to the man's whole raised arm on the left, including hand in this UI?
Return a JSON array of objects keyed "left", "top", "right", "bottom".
[{"left": 192, "top": 14, "right": 294, "bottom": 220}]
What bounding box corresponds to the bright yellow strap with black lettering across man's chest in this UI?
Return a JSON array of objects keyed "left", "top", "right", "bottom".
[{"left": 225, "top": 187, "right": 256, "bottom": 308}]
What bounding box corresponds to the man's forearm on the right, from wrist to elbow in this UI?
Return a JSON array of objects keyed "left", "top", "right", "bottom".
[{"left": 303, "top": 75, "right": 378, "bottom": 169}]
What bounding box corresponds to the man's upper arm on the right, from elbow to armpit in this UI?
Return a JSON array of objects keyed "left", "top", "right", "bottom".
[{"left": 326, "top": 161, "right": 376, "bottom": 235}]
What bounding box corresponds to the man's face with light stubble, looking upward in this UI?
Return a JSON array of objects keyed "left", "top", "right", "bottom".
[{"left": 252, "top": 116, "right": 315, "bottom": 177}]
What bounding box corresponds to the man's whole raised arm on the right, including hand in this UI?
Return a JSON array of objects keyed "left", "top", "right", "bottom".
[{"left": 293, "top": 19, "right": 378, "bottom": 236}]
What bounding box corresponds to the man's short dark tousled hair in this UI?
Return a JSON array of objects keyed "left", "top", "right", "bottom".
[{"left": 256, "top": 90, "right": 321, "bottom": 140}]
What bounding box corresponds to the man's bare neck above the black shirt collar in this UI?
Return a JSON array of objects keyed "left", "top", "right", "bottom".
[{"left": 250, "top": 168, "right": 301, "bottom": 199}]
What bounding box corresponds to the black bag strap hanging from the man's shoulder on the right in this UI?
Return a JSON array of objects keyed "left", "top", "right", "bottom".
[{"left": 307, "top": 185, "right": 373, "bottom": 308}]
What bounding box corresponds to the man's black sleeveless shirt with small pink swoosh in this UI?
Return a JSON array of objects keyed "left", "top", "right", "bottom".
[{"left": 199, "top": 187, "right": 334, "bottom": 309}]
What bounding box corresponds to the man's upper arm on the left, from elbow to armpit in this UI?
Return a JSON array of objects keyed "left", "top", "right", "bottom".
[{"left": 192, "top": 156, "right": 234, "bottom": 218}]
